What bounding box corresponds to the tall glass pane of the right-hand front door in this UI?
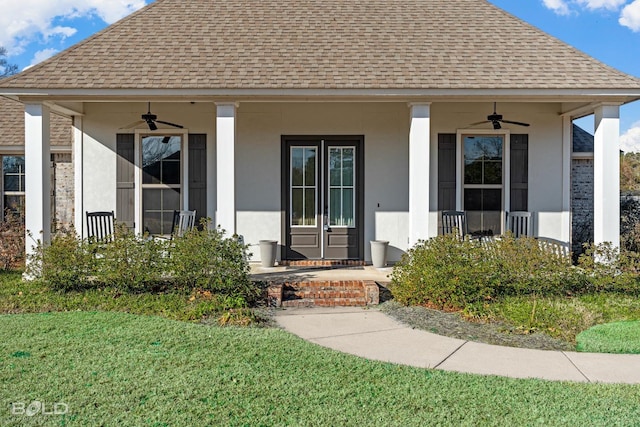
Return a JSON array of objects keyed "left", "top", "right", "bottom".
[{"left": 328, "top": 147, "right": 356, "bottom": 227}]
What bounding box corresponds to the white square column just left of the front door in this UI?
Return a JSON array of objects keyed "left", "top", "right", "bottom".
[{"left": 215, "top": 104, "right": 237, "bottom": 236}]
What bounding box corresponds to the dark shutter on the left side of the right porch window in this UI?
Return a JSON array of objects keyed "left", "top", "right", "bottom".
[{"left": 438, "top": 133, "right": 456, "bottom": 211}]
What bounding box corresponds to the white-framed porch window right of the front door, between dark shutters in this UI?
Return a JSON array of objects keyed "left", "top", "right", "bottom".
[{"left": 462, "top": 135, "right": 504, "bottom": 235}]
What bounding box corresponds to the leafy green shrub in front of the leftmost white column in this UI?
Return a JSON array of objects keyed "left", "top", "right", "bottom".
[{"left": 26, "top": 228, "right": 95, "bottom": 291}]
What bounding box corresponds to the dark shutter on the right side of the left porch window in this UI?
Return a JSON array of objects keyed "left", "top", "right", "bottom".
[{"left": 189, "top": 134, "right": 207, "bottom": 224}]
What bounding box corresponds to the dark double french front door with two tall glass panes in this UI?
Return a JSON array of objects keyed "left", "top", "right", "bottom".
[{"left": 282, "top": 136, "right": 364, "bottom": 260}]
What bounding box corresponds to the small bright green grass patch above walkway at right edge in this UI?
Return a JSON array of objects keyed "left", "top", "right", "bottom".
[{"left": 576, "top": 321, "right": 640, "bottom": 354}]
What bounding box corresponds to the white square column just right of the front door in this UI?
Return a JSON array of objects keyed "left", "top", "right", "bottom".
[{"left": 409, "top": 103, "right": 431, "bottom": 246}]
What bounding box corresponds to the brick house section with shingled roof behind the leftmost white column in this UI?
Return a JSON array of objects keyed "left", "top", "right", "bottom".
[{"left": 0, "top": 96, "right": 75, "bottom": 231}]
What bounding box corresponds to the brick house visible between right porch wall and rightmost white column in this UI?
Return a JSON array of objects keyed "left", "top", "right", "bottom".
[{"left": 571, "top": 125, "right": 593, "bottom": 253}]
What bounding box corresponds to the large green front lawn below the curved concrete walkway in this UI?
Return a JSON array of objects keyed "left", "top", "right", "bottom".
[{"left": 0, "top": 312, "right": 640, "bottom": 426}]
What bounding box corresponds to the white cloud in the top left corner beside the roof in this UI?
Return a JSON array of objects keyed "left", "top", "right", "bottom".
[{"left": 0, "top": 0, "right": 146, "bottom": 56}]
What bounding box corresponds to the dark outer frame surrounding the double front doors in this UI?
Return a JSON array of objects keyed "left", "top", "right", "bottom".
[{"left": 280, "top": 135, "right": 365, "bottom": 260}]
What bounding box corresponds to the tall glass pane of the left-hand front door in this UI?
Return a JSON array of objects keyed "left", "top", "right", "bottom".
[{"left": 290, "top": 147, "right": 318, "bottom": 226}]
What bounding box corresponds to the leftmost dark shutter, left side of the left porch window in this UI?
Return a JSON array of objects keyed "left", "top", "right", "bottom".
[{"left": 116, "top": 134, "right": 136, "bottom": 229}]
